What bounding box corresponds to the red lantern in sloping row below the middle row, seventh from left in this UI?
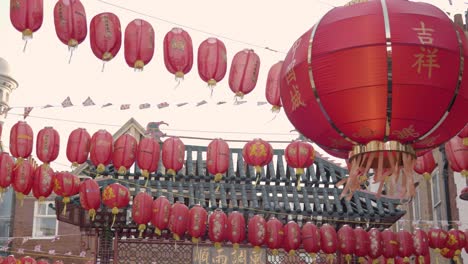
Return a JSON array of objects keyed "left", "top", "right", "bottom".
[{"left": 132, "top": 192, "right": 153, "bottom": 237}]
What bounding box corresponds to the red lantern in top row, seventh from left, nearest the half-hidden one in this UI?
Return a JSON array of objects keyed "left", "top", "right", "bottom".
[{"left": 229, "top": 49, "right": 260, "bottom": 98}]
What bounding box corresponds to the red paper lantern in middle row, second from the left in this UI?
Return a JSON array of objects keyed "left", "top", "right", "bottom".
[{"left": 36, "top": 127, "right": 60, "bottom": 164}]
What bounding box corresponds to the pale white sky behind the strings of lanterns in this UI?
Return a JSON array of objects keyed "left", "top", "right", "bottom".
[{"left": 0, "top": 0, "right": 468, "bottom": 170}]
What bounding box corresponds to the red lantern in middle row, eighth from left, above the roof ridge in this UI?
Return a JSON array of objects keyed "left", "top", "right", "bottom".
[{"left": 206, "top": 139, "right": 229, "bottom": 182}]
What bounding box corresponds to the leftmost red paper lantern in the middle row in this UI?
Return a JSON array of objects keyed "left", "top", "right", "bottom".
[{"left": 10, "top": 121, "right": 34, "bottom": 163}]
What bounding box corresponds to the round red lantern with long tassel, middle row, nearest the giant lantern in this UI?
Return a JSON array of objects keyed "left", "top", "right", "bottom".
[{"left": 284, "top": 140, "right": 315, "bottom": 191}]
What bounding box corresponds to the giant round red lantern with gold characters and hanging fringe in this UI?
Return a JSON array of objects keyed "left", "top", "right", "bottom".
[{"left": 281, "top": 0, "right": 468, "bottom": 199}]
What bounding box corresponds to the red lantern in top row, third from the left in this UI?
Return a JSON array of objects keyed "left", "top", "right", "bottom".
[{"left": 89, "top": 13, "right": 122, "bottom": 70}]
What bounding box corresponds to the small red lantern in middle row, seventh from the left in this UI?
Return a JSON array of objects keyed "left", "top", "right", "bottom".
[{"left": 162, "top": 137, "right": 185, "bottom": 181}]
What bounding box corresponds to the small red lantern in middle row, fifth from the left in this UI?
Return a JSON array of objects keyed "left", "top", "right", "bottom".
[{"left": 112, "top": 134, "right": 138, "bottom": 175}]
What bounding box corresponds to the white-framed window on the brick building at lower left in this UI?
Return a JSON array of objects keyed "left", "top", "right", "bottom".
[{"left": 32, "top": 201, "right": 58, "bottom": 238}]
